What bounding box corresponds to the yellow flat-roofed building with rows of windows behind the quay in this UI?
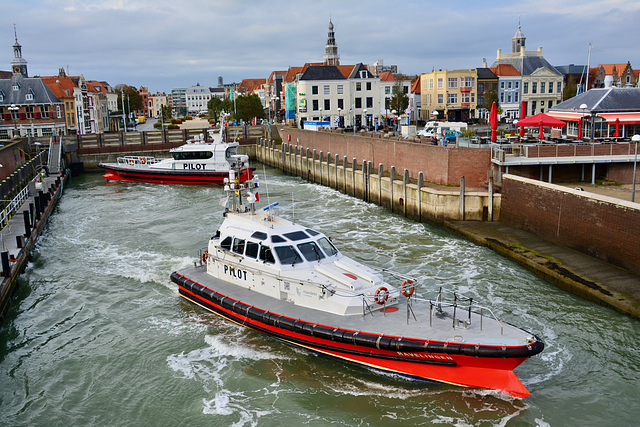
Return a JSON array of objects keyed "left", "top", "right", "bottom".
[{"left": 420, "top": 69, "right": 478, "bottom": 122}]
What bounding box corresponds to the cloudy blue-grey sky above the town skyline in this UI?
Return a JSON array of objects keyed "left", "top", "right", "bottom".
[{"left": 0, "top": 0, "right": 640, "bottom": 92}]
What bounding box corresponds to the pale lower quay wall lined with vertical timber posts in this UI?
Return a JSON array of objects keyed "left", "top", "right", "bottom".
[{"left": 256, "top": 140, "right": 501, "bottom": 223}]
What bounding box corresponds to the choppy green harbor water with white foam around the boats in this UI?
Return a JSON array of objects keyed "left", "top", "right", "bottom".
[{"left": 0, "top": 167, "right": 640, "bottom": 426}]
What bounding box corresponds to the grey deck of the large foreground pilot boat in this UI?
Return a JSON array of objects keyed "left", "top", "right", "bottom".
[{"left": 178, "top": 266, "right": 533, "bottom": 347}]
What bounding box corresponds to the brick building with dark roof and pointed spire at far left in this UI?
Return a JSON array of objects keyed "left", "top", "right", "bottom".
[{"left": 0, "top": 31, "right": 65, "bottom": 140}]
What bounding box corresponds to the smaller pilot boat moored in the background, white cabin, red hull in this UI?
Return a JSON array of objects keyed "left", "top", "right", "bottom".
[{"left": 98, "top": 127, "right": 253, "bottom": 184}]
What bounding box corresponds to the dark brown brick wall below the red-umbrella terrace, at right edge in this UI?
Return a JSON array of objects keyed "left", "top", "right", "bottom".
[{"left": 500, "top": 175, "right": 640, "bottom": 274}]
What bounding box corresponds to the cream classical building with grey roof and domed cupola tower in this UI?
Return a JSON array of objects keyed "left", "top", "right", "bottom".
[{"left": 491, "top": 22, "right": 563, "bottom": 116}]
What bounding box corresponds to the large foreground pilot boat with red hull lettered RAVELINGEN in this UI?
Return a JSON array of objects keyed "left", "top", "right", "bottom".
[{"left": 171, "top": 173, "right": 544, "bottom": 398}]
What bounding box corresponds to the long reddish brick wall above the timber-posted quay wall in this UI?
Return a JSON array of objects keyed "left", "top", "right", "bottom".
[{"left": 279, "top": 127, "right": 491, "bottom": 188}]
